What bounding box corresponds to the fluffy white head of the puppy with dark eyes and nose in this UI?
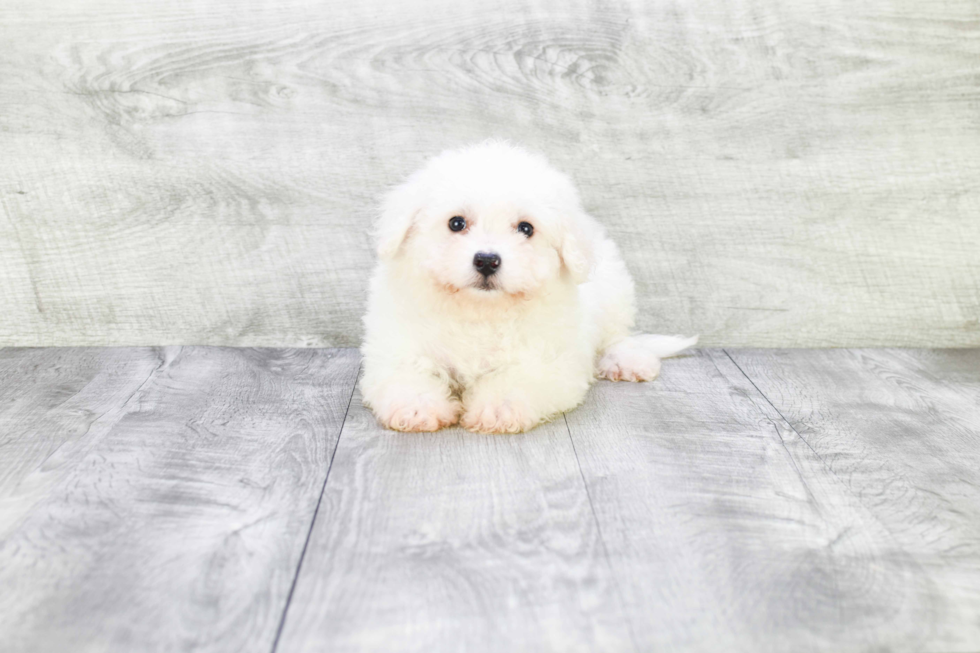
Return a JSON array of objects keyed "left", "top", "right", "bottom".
[{"left": 376, "top": 141, "right": 596, "bottom": 300}]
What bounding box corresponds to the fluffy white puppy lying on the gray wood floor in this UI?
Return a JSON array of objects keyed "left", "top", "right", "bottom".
[{"left": 362, "top": 141, "right": 697, "bottom": 433}]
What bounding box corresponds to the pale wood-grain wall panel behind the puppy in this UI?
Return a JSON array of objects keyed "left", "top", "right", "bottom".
[{"left": 0, "top": 0, "right": 980, "bottom": 346}]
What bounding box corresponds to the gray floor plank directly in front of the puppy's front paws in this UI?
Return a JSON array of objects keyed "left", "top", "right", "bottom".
[{"left": 277, "top": 382, "right": 632, "bottom": 653}]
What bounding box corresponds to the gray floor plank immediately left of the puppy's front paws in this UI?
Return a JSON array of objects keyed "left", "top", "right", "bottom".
[{"left": 0, "top": 347, "right": 359, "bottom": 653}]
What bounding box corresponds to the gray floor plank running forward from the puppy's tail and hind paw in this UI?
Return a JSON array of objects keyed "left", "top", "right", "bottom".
[{"left": 568, "top": 350, "right": 967, "bottom": 651}]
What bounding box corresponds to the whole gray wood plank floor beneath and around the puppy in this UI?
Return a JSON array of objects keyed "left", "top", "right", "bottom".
[{"left": 0, "top": 347, "right": 980, "bottom": 653}]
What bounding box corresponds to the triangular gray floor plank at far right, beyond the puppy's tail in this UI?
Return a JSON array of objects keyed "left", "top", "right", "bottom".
[{"left": 729, "top": 350, "right": 980, "bottom": 651}]
